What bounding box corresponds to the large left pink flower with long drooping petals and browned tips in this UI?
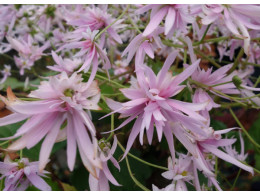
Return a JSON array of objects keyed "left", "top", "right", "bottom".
[{"left": 0, "top": 72, "right": 102, "bottom": 177}]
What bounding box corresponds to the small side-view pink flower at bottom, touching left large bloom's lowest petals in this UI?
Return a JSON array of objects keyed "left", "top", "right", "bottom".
[{"left": 89, "top": 136, "right": 120, "bottom": 191}]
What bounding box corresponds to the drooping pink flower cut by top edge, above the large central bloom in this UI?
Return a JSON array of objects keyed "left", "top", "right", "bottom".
[{"left": 136, "top": 4, "right": 194, "bottom": 37}]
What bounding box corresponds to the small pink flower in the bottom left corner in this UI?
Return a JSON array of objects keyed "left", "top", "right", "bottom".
[{"left": 0, "top": 156, "right": 51, "bottom": 191}]
